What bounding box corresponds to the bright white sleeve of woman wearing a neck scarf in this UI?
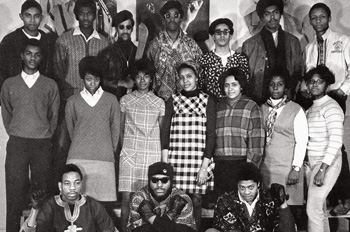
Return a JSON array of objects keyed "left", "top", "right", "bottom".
[{"left": 292, "top": 109, "right": 309, "bottom": 167}]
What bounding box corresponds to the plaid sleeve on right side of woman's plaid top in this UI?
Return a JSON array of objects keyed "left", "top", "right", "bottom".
[{"left": 247, "top": 103, "right": 265, "bottom": 166}]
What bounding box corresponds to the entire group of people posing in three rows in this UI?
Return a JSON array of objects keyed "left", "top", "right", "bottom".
[{"left": 0, "top": 0, "right": 350, "bottom": 232}]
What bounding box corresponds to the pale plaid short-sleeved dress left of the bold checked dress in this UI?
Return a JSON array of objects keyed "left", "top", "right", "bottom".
[{"left": 119, "top": 90, "right": 165, "bottom": 192}]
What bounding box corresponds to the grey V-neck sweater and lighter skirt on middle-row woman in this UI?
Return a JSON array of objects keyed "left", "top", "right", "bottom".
[{"left": 66, "top": 92, "right": 120, "bottom": 201}]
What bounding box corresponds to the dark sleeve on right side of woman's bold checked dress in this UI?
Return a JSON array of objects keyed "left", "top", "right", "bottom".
[{"left": 204, "top": 97, "right": 216, "bottom": 159}]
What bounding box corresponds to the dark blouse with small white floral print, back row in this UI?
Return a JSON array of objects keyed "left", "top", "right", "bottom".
[{"left": 198, "top": 51, "right": 249, "bottom": 100}]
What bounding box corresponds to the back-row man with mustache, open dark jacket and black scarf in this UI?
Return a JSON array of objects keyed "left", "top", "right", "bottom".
[{"left": 242, "top": 0, "right": 303, "bottom": 105}]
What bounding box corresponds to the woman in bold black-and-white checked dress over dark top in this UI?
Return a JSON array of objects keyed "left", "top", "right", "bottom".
[{"left": 162, "top": 62, "right": 216, "bottom": 229}]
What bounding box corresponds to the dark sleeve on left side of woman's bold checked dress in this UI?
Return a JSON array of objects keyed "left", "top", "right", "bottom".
[{"left": 161, "top": 97, "right": 174, "bottom": 149}]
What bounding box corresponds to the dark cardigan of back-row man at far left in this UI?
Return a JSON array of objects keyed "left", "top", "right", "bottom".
[{"left": 0, "top": 27, "right": 57, "bottom": 88}]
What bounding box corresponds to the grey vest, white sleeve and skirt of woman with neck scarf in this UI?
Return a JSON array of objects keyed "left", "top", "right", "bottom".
[{"left": 260, "top": 101, "right": 308, "bottom": 205}]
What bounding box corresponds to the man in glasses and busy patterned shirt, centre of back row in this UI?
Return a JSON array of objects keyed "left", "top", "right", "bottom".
[{"left": 147, "top": 1, "right": 202, "bottom": 100}]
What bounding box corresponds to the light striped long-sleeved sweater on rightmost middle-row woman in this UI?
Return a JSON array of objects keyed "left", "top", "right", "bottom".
[{"left": 306, "top": 95, "right": 344, "bottom": 165}]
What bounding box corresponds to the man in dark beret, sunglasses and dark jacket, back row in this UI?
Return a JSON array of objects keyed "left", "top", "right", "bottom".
[{"left": 99, "top": 10, "right": 137, "bottom": 100}]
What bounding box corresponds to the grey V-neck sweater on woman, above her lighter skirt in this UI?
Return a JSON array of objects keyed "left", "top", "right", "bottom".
[{"left": 66, "top": 92, "right": 120, "bottom": 162}]
